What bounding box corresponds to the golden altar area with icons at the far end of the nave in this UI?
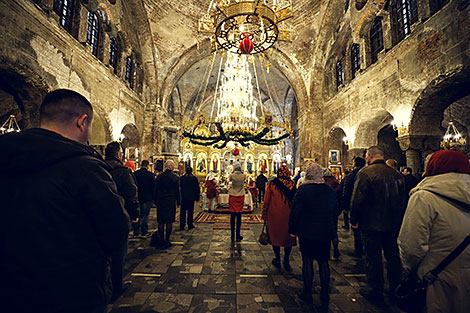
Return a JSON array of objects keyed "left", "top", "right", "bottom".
[{"left": 178, "top": 138, "right": 291, "bottom": 213}]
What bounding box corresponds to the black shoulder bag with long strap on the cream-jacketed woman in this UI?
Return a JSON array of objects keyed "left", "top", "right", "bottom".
[{"left": 395, "top": 235, "right": 470, "bottom": 313}]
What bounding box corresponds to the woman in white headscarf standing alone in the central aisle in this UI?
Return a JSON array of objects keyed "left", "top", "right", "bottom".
[{"left": 228, "top": 163, "right": 245, "bottom": 242}]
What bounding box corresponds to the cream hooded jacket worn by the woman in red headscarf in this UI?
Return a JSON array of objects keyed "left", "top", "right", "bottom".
[{"left": 398, "top": 173, "right": 470, "bottom": 313}]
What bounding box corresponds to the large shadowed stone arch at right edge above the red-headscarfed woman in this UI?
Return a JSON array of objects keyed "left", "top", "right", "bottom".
[{"left": 409, "top": 67, "right": 470, "bottom": 136}]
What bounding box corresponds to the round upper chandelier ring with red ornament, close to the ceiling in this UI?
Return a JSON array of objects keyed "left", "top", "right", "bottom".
[{"left": 198, "top": 0, "right": 292, "bottom": 54}]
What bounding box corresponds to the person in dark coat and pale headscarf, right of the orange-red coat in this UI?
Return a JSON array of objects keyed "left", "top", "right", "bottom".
[{"left": 289, "top": 163, "right": 338, "bottom": 307}]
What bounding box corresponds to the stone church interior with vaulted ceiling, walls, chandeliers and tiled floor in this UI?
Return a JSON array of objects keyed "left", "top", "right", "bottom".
[{"left": 0, "top": 0, "right": 470, "bottom": 312}]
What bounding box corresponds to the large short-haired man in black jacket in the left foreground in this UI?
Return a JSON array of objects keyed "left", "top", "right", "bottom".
[{"left": 0, "top": 90, "right": 129, "bottom": 313}]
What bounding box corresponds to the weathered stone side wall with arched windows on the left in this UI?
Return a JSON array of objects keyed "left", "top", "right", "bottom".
[{"left": 0, "top": 0, "right": 157, "bottom": 157}]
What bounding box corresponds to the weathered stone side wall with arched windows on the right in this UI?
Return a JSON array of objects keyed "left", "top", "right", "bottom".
[{"left": 313, "top": 0, "right": 470, "bottom": 172}]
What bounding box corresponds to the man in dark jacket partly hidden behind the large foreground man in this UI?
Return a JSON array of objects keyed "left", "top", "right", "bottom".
[{"left": 104, "top": 141, "right": 140, "bottom": 302}]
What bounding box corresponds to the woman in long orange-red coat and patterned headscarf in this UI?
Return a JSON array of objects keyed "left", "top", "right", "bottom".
[{"left": 263, "top": 165, "right": 297, "bottom": 271}]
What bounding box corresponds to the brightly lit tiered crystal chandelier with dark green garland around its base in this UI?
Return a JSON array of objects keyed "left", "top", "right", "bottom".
[{"left": 182, "top": 53, "right": 291, "bottom": 149}]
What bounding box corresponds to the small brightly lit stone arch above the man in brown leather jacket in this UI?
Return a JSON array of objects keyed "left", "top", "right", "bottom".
[{"left": 354, "top": 110, "right": 393, "bottom": 148}]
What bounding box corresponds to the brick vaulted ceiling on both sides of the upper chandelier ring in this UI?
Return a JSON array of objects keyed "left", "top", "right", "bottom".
[{"left": 143, "top": 0, "right": 328, "bottom": 118}]
